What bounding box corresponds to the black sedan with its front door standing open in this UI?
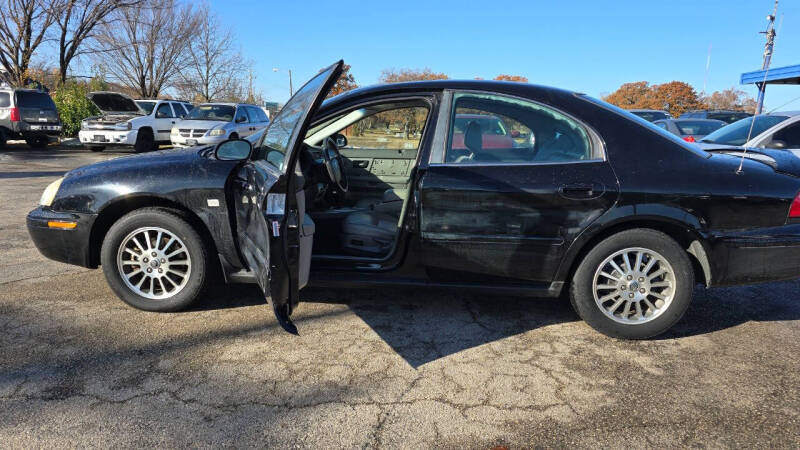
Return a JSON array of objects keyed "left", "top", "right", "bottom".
[{"left": 28, "top": 61, "right": 800, "bottom": 339}]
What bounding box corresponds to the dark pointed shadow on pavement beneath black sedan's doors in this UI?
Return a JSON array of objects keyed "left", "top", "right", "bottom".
[{"left": 300, "top": 288, "right": 578, "bottom": 369}]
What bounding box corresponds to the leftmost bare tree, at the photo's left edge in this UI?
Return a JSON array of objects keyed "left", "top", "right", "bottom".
[{"left": 0, "top": 0, "right": 56, "bottom": 86}]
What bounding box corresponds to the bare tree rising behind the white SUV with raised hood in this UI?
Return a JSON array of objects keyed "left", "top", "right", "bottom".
[{"left": 94, "top": 0, "right": 201, "bottom": 98}]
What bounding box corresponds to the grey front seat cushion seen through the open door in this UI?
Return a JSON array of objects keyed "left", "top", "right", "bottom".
[{"left": 341, "top": 211, "right": 398, "bottom": 256}]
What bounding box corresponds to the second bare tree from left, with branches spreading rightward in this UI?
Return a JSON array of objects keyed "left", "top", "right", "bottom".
[{"left": 50, "top": 0, "right": 141, "bottom": 83}]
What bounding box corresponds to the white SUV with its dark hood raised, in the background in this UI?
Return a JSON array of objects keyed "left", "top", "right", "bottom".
[{"left": 78, "top": 92, "right": 192, "bottom": 153}]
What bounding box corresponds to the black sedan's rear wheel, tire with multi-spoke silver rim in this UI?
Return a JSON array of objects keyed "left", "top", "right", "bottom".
[{"left": 570, "top": 228, "right": 694, "bottom": 339}]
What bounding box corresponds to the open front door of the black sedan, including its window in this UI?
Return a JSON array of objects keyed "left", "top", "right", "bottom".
[{"left": 231, "top": 60, "right": 344, "bottom": 334}]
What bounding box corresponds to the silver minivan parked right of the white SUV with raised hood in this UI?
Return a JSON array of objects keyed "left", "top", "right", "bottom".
[{"left": 170, "top": 103, "right": 269, "bottom": 147}]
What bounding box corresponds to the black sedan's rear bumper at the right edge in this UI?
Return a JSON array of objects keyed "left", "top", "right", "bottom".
[{"left": 711, "top": 224, "right": 800, "bottom": 286}]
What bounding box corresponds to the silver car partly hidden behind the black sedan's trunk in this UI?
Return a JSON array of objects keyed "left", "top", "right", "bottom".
[{"left": 698, "top": 111, "right": 800, "bottom": 156}]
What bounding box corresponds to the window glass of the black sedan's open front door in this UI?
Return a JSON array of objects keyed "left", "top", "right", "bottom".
[{"left": 254, "top": 64, "right": 337, "bottom": 170}]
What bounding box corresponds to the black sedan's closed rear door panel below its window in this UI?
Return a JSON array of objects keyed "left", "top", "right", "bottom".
[{"left": 420, "top": 161, "right": 617, "bottom": 283}]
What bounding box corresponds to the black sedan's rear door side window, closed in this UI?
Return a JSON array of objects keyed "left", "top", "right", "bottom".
[{"left": 445, "top": 94, "right": 598, "bottom": 164}]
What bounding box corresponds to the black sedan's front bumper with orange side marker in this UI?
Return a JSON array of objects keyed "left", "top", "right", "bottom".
[{"left": 27, "top": 206, "right": 97, "bottom": 267}]
